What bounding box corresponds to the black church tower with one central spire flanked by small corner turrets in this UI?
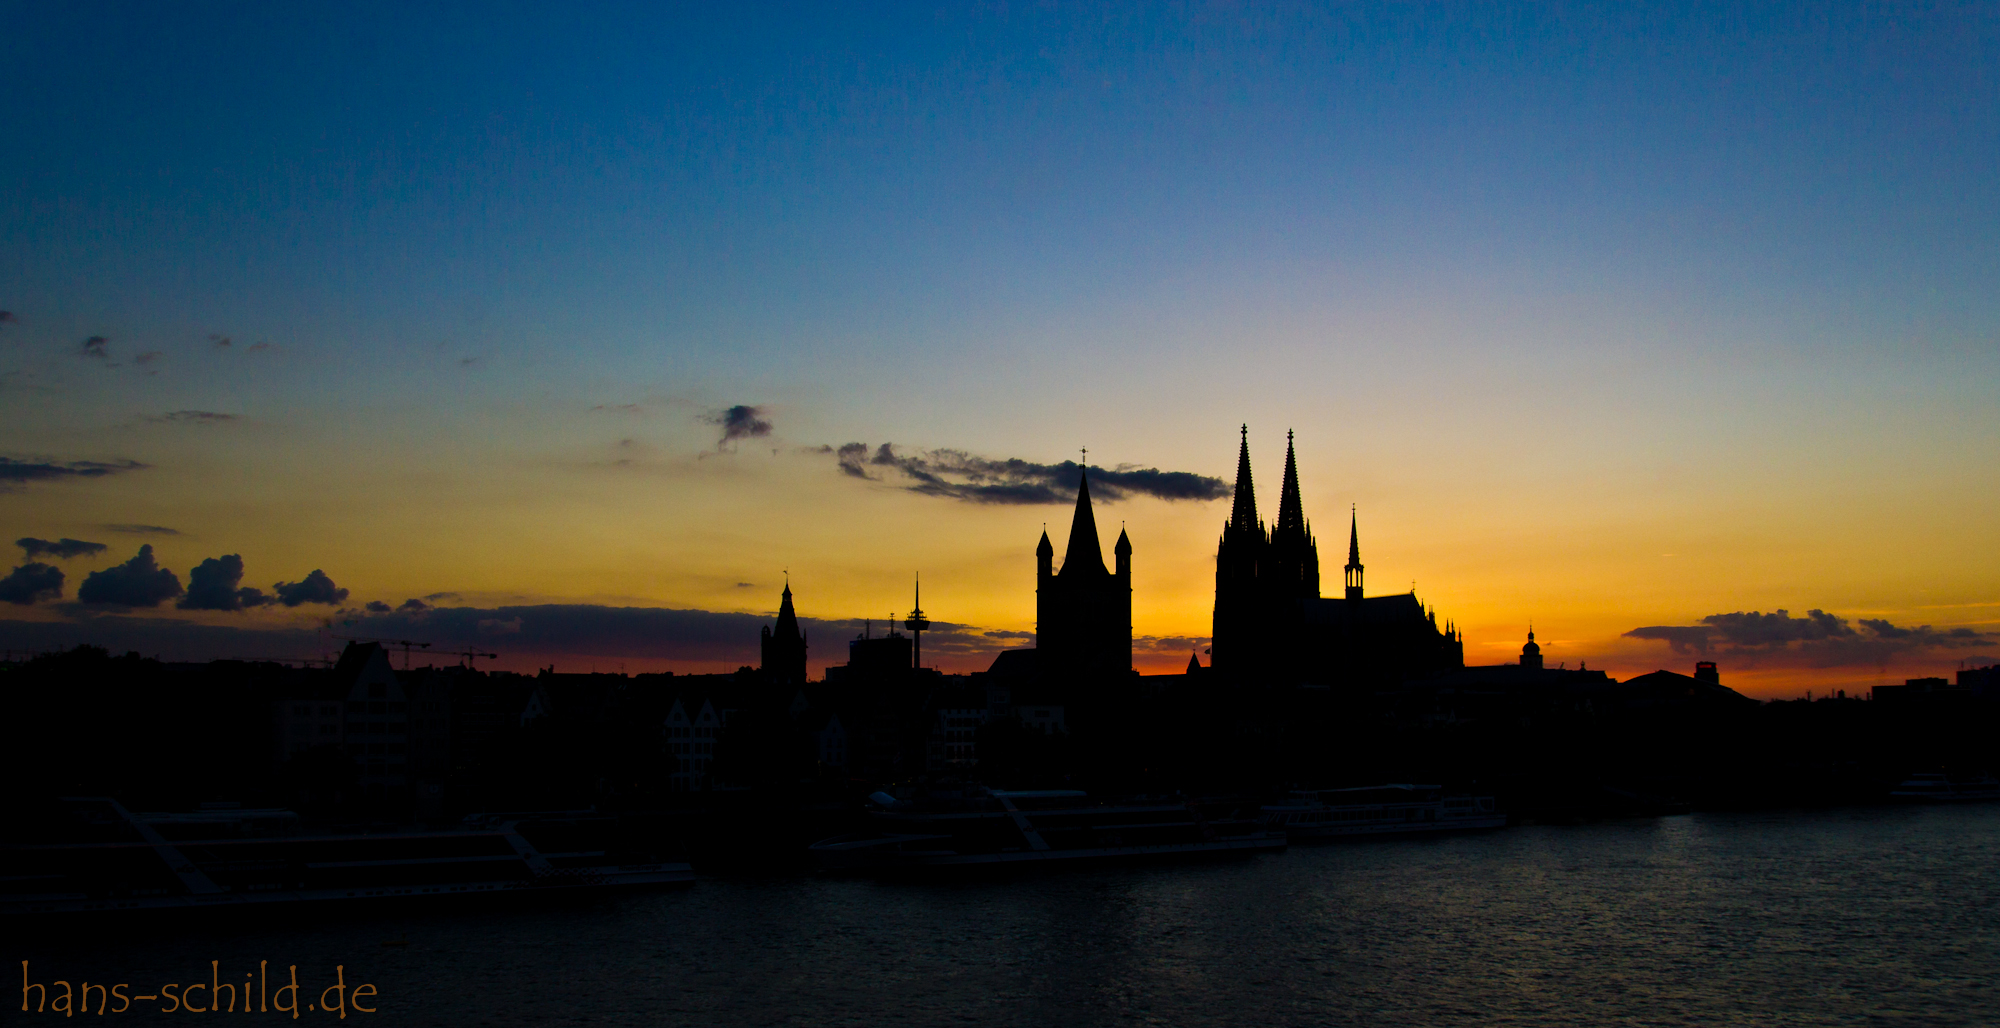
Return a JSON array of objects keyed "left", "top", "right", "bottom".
[{"left": 1034, "top": 470, "right": 1132, "bottom": 678}]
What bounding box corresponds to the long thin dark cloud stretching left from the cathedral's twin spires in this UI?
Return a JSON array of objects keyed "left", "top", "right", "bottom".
[{"left": 832, "top": 442, "right": 1230, "bottom": 504}]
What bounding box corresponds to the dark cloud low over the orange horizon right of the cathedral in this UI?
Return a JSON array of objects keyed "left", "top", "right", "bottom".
[{"left": 1626, "top": 608, "right": 2000, "bottom": 668}]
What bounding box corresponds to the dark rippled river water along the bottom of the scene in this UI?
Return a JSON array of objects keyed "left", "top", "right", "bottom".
[{"left": 31, "top": 804, "right": 2000, "bottom": 1026}]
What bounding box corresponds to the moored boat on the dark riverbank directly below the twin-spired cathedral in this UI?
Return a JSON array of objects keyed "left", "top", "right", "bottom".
[{"left": 1262, "top": 784, "right": 1506, "bottom": 840}]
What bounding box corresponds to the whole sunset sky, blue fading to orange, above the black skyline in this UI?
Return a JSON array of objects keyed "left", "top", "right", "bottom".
[{"left": 0, "top": 4, "right": 2000, "bottom": 696}]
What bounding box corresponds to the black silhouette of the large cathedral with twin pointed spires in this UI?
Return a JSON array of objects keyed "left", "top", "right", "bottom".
[{"left": 1210, "top": 426, "right": 1466, "bottom": 688}]
